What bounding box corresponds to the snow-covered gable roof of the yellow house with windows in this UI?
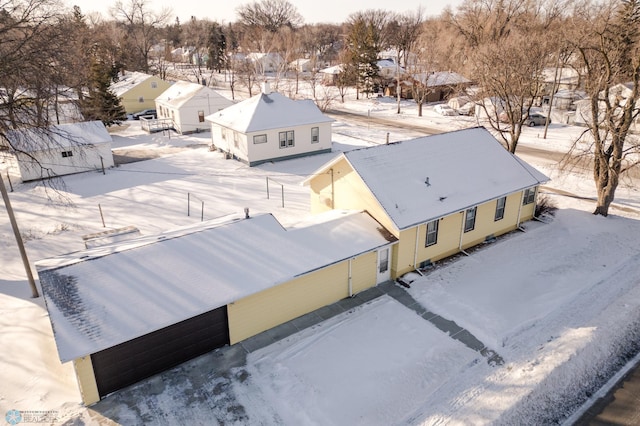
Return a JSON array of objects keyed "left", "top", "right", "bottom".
[{"left": 306, "top": 127, "right": 549, "bottom": 230}]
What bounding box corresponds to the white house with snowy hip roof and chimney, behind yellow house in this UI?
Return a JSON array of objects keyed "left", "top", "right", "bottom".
[{"left": 206, "top": 83, "right": 333, "bottom": 166}]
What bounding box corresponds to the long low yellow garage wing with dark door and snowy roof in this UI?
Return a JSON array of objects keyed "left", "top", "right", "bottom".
[{"left": 36, "top": 212, "right": 395, "bottom": 405}]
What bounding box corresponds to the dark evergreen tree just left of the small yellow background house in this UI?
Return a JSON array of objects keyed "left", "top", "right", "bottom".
[{"left": 80, "top": 59, "right": 127, "bottom": 126}]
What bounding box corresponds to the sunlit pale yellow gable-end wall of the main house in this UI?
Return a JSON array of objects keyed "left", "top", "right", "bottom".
[{"left": 310, "top": 159, "right": 398, "bottom": 237}]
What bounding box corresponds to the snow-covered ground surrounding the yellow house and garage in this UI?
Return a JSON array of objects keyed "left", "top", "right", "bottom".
[{"left": 0, "top": 85, "right": 640, "bottom": 425}]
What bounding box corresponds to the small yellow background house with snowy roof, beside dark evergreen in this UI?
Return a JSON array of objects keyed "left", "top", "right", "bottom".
[{"left": 111, "top": 71, "right": 171, "bottom": 114}]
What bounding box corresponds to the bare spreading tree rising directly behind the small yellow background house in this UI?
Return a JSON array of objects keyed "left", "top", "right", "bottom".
[{"left": 111, "top": 0, "right": 171, "bottom": 72}]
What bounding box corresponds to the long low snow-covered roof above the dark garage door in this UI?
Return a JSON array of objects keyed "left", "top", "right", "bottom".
[{"left": 36, "top": 212, "right": 395, "bottom": 362}]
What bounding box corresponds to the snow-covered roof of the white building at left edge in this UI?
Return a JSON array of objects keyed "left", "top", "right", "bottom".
[{"left": 6, "top": 120, "right": 112, "bottom": 152}]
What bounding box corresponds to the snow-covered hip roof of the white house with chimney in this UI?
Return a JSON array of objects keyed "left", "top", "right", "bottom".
[{"left": 205, "top": 92, "right": 334, "bottom": 133}]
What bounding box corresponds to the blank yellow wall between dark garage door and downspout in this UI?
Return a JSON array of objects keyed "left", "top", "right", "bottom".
[{"left": 227, "top": 261, "right": 350, "bottom": 344}]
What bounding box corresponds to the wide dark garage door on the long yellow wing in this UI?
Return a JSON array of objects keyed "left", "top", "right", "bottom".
[{"left": 91, "top": 306, "right": 229, "bottom": 397}]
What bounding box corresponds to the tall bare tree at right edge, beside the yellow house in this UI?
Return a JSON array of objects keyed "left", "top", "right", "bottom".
[{"left": 576, "top": 0, "right": 640, "bottom": 216}]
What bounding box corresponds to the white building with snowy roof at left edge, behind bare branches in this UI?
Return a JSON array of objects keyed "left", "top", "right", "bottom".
[{"left": 0, "top": 121, "right": 114, "bottom": 182}]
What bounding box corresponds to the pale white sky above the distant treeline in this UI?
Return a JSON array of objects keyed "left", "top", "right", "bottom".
[{"left": 64, "top": 0, "right": 462, "bottom": 23}]
